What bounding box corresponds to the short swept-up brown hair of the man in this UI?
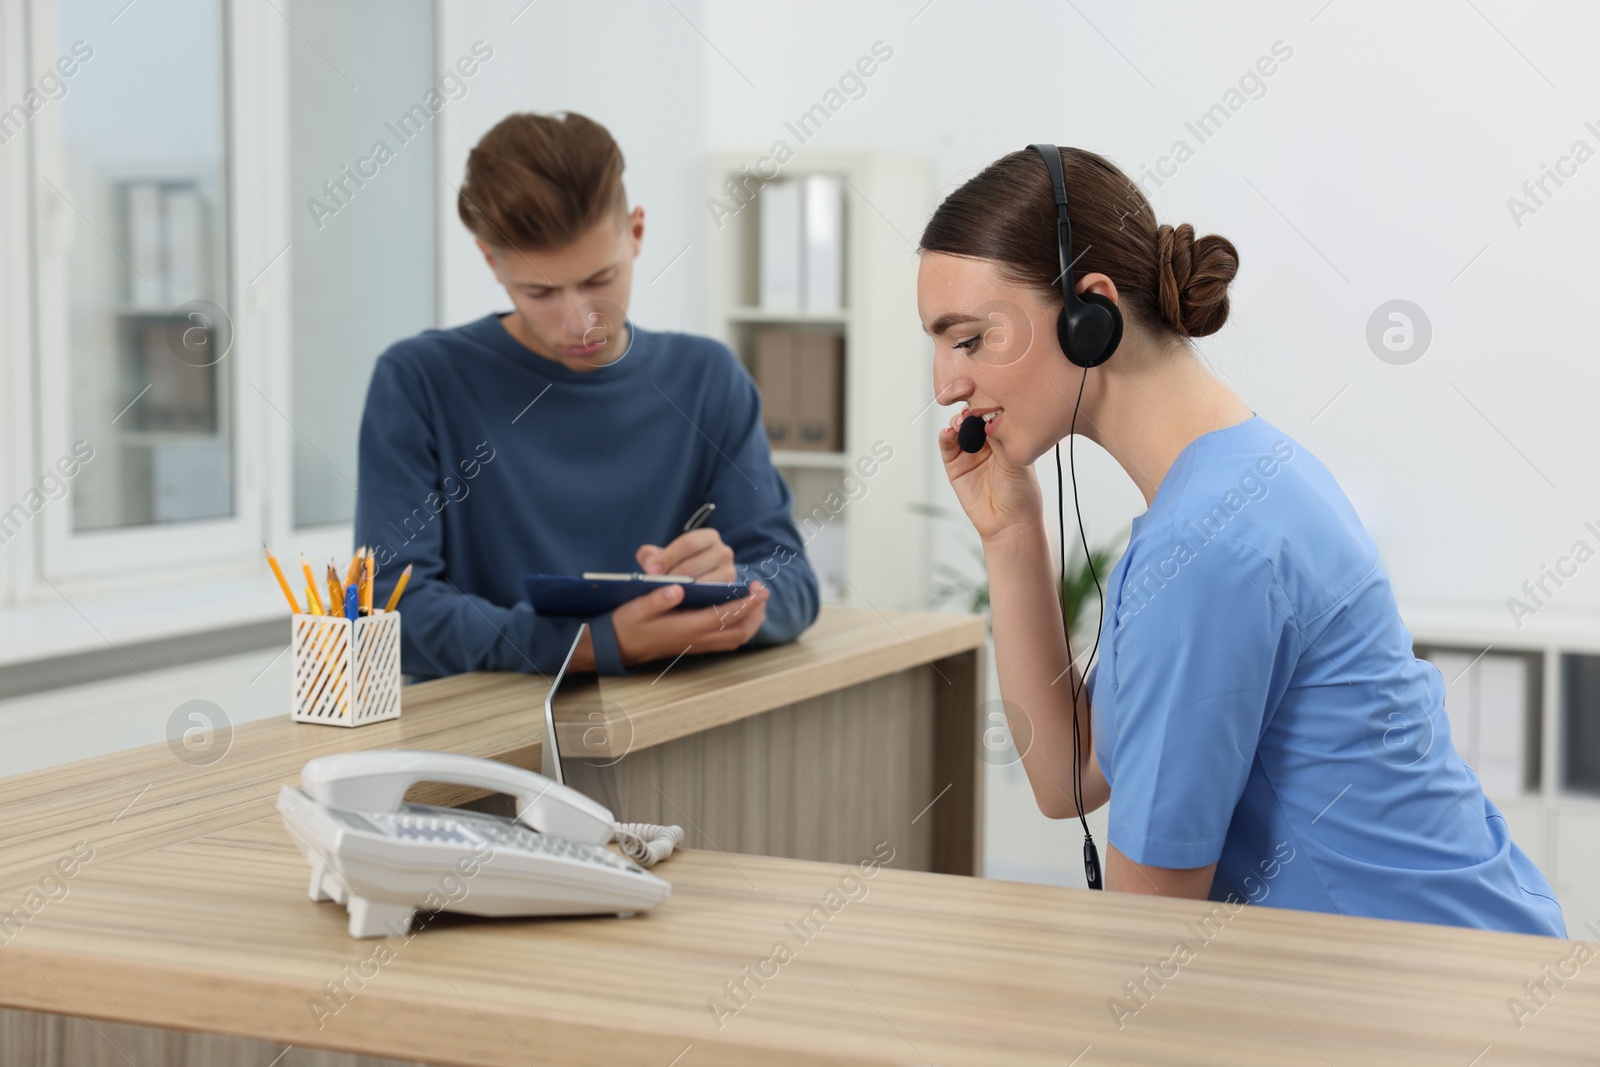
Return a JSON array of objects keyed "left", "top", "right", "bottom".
[{"left": 456, "top": 112, "right": 627, "bottom": 250}]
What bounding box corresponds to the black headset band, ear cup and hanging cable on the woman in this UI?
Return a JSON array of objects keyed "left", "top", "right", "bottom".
[{"left": 1029, "top": 144, "right": 1122, "bottom": 889}]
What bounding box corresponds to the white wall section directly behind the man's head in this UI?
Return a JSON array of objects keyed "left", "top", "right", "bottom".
[{"left": 438, "top": 0, "right": 706, "bottom": 330}]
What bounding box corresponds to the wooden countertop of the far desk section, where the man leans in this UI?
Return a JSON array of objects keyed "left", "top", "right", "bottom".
[{"left": 0, "top": 608, "right": 984, "bottom": 901}]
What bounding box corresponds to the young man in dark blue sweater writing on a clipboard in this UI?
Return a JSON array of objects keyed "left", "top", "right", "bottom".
[{"left": 355, "top": 114, "right": 818, "bottom": 678}]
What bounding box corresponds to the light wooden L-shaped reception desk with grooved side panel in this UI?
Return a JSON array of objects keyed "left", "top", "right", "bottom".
[{"left": 0, "top": 613, "right": 1600, "bottom": 1067}]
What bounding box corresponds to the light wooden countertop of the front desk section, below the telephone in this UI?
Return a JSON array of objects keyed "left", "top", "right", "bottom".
[{"left": 0, "top": 814, "right": 1600, "bottom": 1067}]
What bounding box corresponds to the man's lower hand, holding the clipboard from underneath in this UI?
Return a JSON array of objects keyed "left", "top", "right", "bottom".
[{"left": 611, "top": 575, "right": 771, "bottom": 667}]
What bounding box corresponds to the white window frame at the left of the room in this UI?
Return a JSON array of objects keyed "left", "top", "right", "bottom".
[{"left": 16, "top": 0, "right": 352, "bottom": 603}]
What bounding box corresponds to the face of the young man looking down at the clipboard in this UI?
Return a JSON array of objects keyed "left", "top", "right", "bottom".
[{"left": 478, "top": 208, "right": 645, "bottom": 371}]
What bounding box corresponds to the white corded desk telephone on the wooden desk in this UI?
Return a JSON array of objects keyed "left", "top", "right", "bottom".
[{"left": 278, "top": 750, "right": 683, "bottom": 937}]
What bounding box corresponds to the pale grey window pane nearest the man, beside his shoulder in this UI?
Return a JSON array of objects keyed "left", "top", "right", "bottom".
[{"left": 286, "top": 0, "right": 438, "bottom": 526}]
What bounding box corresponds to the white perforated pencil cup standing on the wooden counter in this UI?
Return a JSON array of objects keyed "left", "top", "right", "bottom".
[{"left": 290, "top": 611, "right": 400, "bottom": 726}]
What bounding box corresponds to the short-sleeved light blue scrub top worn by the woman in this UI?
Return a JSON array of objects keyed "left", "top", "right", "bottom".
[{"left": 1088, "top": 416, "right": 1566, "bottom": 937}]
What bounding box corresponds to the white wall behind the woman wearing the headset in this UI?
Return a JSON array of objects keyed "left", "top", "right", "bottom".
[{"left": 702, "top": 0, "right": 1600, "bottom": 617}]
